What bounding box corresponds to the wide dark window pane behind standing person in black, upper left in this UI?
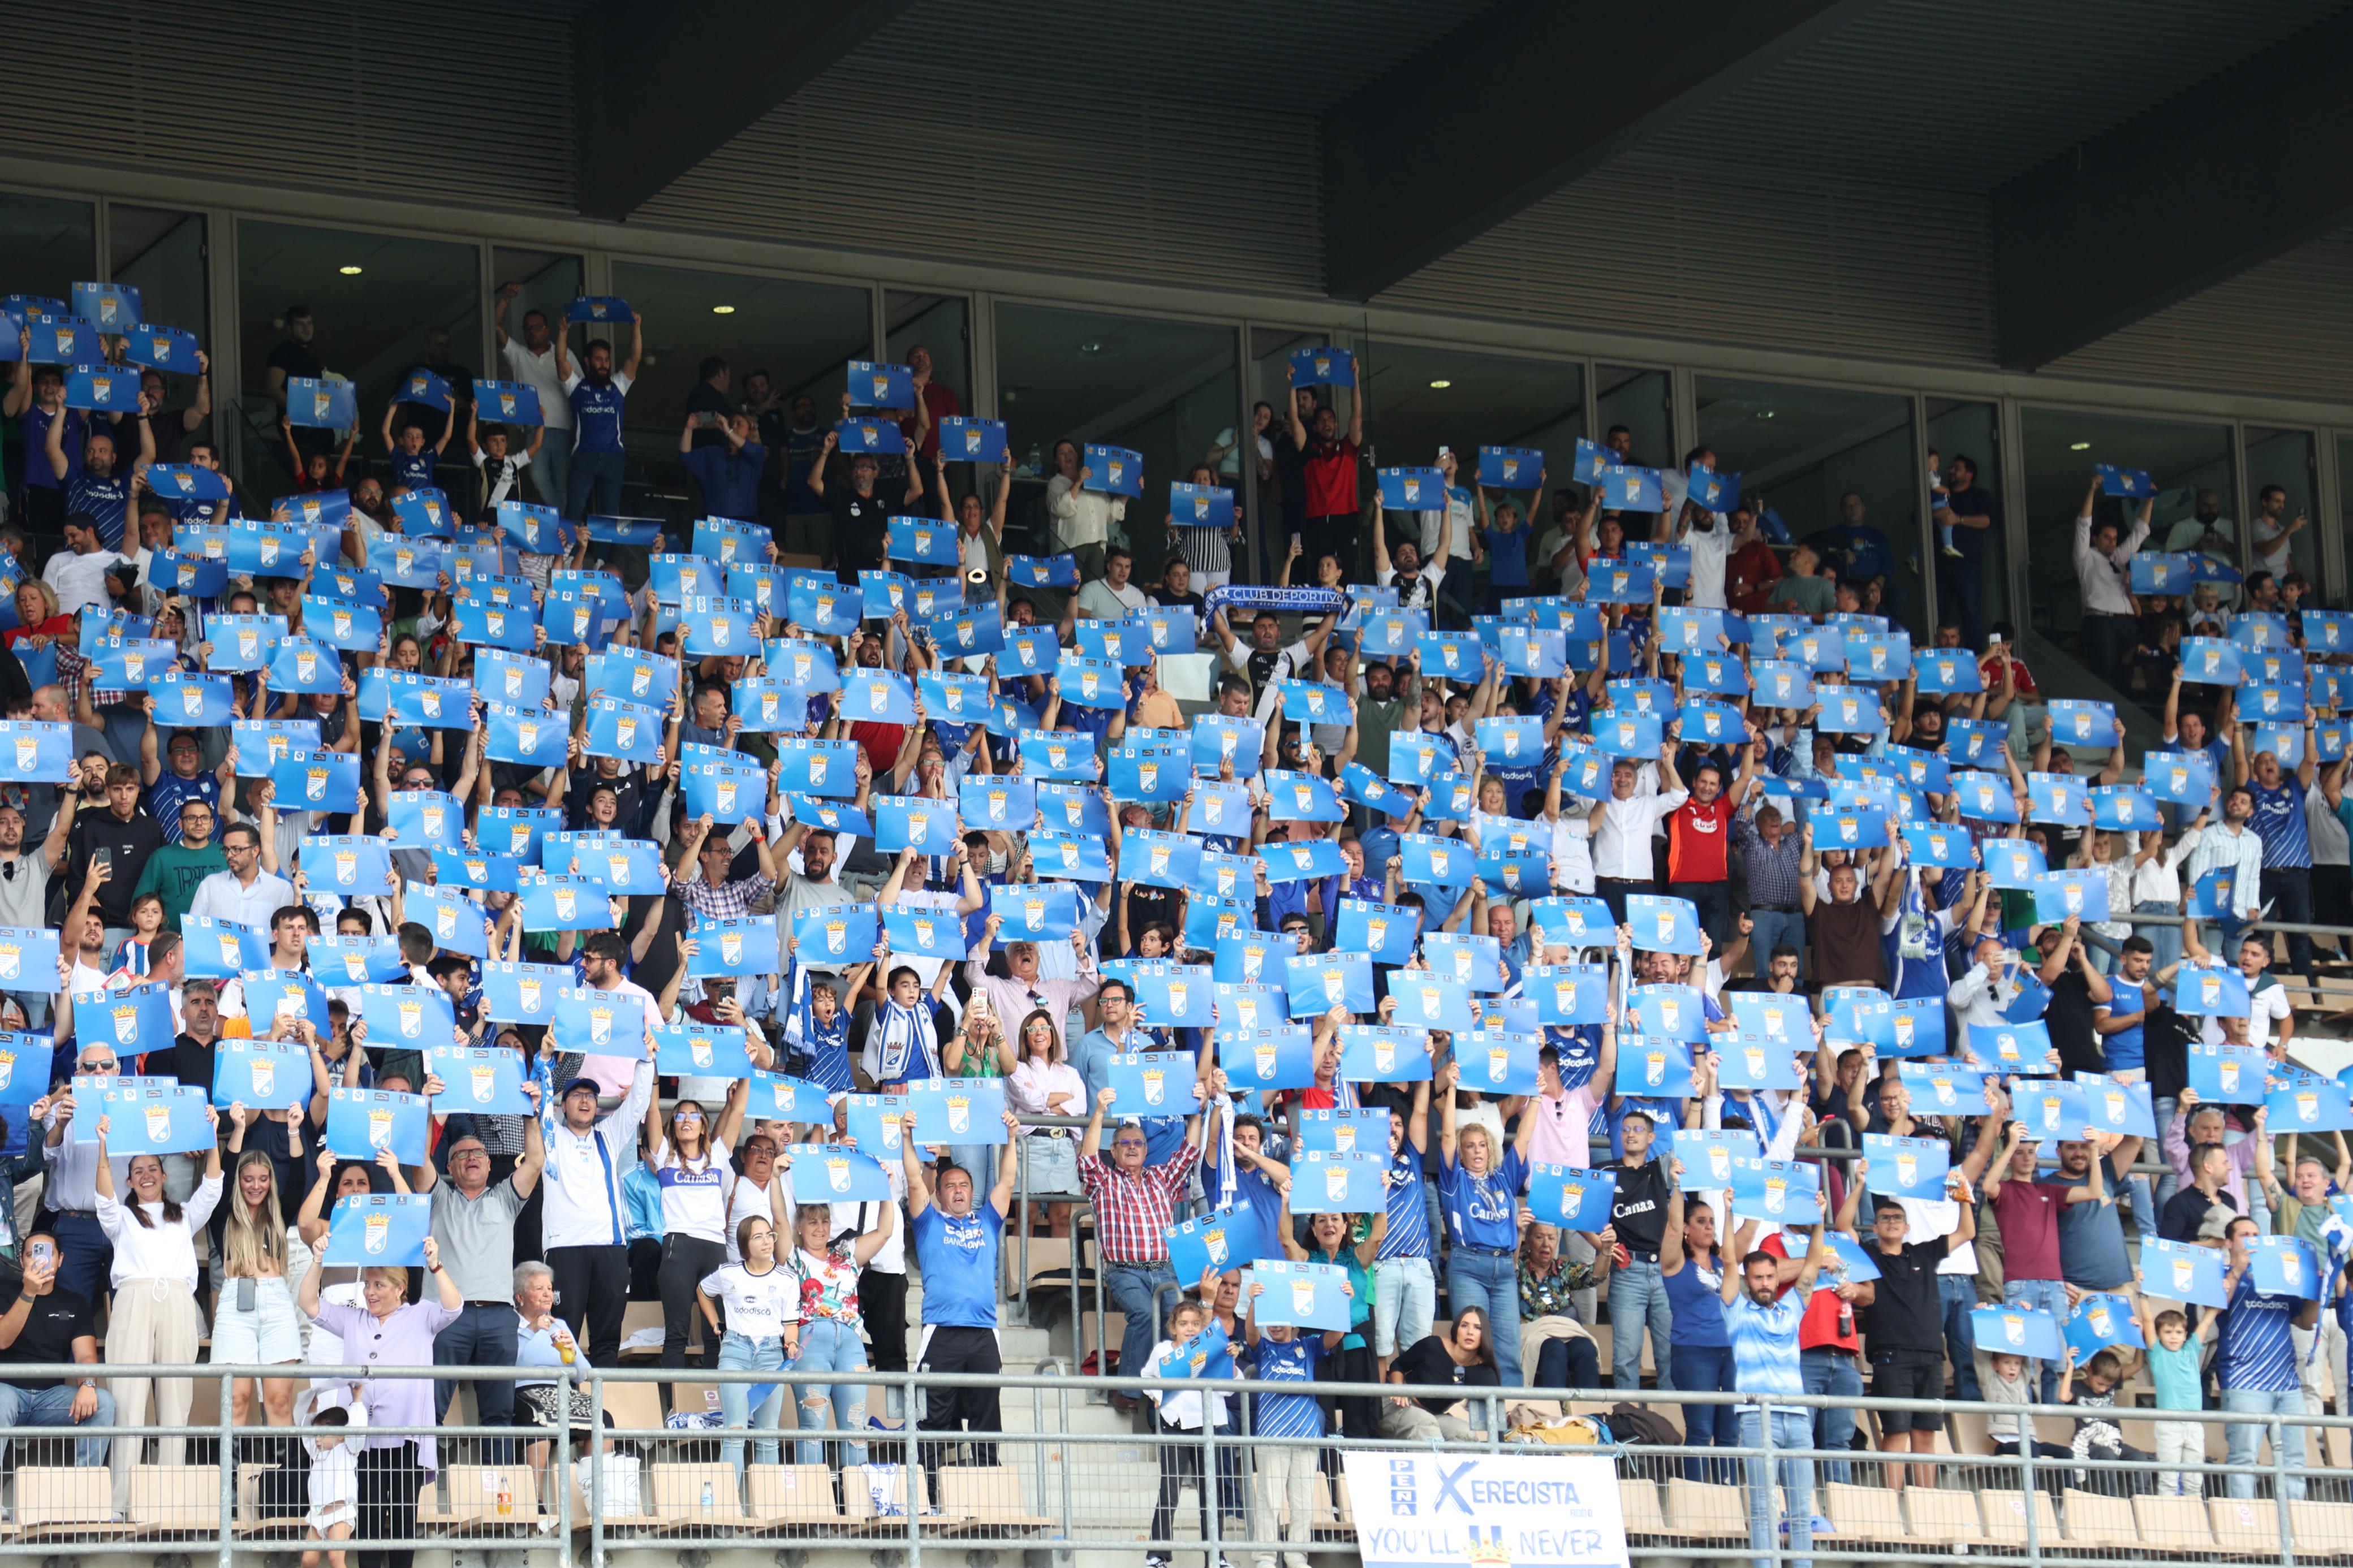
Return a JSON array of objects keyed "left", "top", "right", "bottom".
[{"left": 236, "top": 221, "right": 482, "bottom": 501}]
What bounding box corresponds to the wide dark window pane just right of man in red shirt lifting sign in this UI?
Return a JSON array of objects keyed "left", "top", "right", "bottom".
[{"left": 1365, "top": 341, "right": 1586, "bottom": 623}]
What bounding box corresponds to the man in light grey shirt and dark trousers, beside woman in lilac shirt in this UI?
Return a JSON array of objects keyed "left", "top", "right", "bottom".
[{"left": 416, "top": 1079, "right": 546, "bottom": 1465}]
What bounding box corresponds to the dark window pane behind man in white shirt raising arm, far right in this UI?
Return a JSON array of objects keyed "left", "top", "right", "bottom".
[{"left": 2019, "top": 409, "right": 2240, "bottom": 705}]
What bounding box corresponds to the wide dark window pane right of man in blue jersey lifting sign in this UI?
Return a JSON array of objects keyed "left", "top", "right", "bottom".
[{"left": 607, "top": 261, "right": 875, "bottom": 535}]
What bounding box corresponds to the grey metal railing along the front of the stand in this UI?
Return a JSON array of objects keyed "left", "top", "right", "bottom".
[{"left": 0, "top": 1359, "right": 2353, "bottom": 1568}]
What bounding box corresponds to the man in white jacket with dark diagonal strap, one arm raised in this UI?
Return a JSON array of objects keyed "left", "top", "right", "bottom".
[{"left": 539, "top": 1062, "right": 654, "bottom": 1366}]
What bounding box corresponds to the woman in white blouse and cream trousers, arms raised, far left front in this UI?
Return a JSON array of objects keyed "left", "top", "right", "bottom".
[{"left": 97, "top": 1105, "right": 221, "bottom": 1509}]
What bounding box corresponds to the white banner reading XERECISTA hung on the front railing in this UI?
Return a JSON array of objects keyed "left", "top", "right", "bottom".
[{"left": 1341, "top": 1448, "right": 1626, "bottom": 1568}]
